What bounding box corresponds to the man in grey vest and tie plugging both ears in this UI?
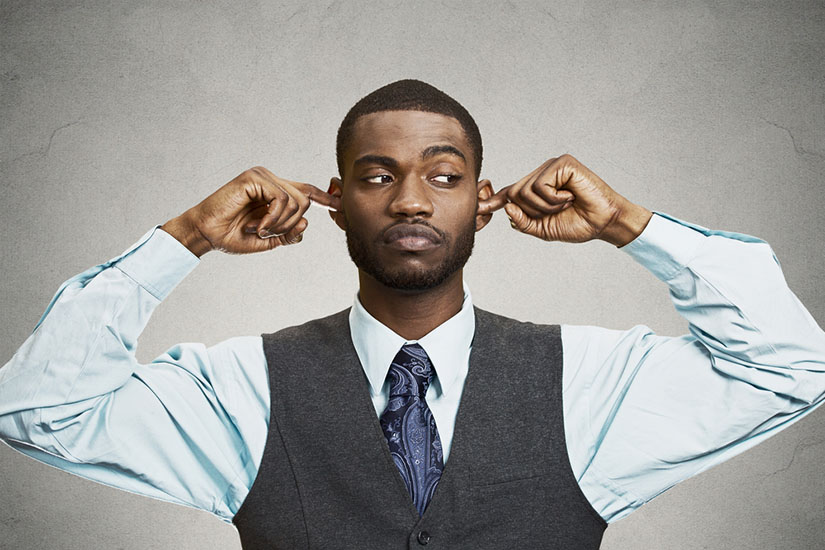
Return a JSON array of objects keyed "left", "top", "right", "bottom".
[{"left": 0, "top": 81, "right": 825, "bottom": 549}]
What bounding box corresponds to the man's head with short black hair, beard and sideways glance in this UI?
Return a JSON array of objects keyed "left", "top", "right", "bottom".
[{"left": 329, "top": 80, "right": 492, "bottom": 291}]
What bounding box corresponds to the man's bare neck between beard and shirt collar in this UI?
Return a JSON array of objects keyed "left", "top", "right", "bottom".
[{"left": 358, "top": 270, "right": 464, "bottom": 340}]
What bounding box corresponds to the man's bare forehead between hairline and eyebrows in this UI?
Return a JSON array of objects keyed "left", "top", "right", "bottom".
[{"left": 345, "top": 111, "right": 472, "bottom": 164}]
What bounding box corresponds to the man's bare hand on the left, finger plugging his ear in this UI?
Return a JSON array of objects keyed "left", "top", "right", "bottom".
[{"left": 161, "top": 166, "right": 341, "bottom": 256}]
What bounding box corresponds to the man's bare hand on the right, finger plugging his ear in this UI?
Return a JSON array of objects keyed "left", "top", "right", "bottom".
[{"left": 479, "top": 155, "right": 652, "bottom": 246}]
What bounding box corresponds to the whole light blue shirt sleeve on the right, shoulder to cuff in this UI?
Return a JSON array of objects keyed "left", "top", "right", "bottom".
[{"left": 562, "top": 214, "right": 825, "bottom": 522}]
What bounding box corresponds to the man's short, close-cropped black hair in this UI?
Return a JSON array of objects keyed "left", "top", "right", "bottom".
[{"left": 335, "top": 79, "right": 483, "bottom": 177}]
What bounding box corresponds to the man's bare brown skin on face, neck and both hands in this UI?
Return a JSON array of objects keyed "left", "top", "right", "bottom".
[{"left": 161, "top": 111, "right": 652, "bottom": 340}]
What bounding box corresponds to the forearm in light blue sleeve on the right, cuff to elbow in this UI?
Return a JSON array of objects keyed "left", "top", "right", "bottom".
[{"left": 625, "top": 218, "right": 825, "bottom": 396}]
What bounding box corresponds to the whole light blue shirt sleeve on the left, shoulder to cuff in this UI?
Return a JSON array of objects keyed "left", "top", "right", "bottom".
[{"left": 0, "top": 228, "right": 269, "bottom": 521}]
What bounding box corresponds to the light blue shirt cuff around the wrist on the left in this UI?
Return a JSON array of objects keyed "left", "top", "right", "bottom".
[{"left": 115, "top": 227, "right": 200, "bottom": 300}]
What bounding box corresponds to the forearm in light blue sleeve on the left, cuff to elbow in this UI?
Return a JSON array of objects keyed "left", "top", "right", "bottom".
[{"left": 0, "top": 231, "right": 197, "bottom": 417}]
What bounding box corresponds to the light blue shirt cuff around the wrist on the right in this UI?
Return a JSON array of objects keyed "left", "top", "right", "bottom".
[{"left": 620, "top": 212, "right": 705, "bottom": 282}]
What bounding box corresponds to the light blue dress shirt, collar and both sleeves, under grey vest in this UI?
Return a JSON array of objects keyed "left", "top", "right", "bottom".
[{"left": 0, "top": 214, "right": 825, "bottom": 522}]
